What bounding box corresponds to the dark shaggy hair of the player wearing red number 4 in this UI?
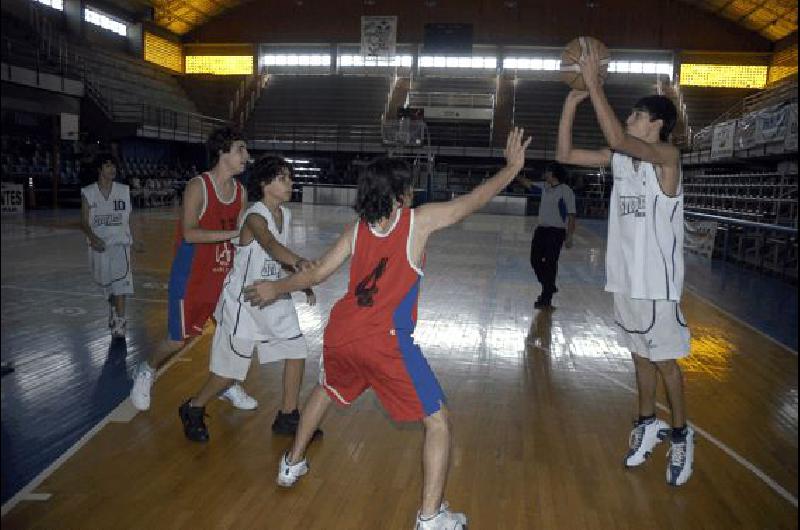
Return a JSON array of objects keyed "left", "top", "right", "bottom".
[{"left": 353, "top": 158, "right": 413, "bottom": 223}]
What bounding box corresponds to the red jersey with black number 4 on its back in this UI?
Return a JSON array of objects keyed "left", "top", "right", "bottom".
[{"left": 325, "top": 208, "right": 423, "bottom": 346}]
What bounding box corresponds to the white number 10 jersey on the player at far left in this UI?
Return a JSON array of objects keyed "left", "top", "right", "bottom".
[{"left": 81, "top": 182, "right": 131, "bottom": 245}]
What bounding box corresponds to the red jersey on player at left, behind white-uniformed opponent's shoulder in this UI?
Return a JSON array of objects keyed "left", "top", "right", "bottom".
[{"left": 172, "top": 173, "right": 243, "bottom": 302}]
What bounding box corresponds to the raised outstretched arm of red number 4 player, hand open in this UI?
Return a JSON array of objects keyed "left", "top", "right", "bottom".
[{"left": 414, "top": 127, "right": 531, "bottom": 237}]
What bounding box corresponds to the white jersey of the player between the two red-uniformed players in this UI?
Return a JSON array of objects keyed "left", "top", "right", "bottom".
[{"left": 214, "top": 201, "right": 302, "bottom": 340}]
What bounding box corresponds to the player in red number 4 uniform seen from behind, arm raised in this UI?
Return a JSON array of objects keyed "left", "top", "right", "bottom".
[{"left": 245, "top": 128, "right": 530, "bottom": 530}]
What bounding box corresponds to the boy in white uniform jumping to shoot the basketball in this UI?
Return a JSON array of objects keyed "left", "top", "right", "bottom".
[{"left": 556, "top": 39, "right": 694, "bottom": 486}]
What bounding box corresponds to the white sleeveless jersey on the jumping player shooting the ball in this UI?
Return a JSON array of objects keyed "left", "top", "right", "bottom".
[{"left": 606, "top": 153, "right": 684, "bottom": 301}]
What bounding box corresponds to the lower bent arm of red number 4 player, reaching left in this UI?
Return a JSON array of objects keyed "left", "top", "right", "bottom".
[{"left": 244, "top": 225, "right": 355, "bottom": 307}]
